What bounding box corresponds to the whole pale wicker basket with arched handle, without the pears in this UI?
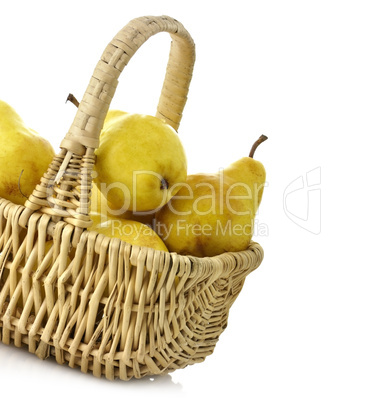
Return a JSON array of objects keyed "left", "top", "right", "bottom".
[{"left": 0, "top": 16, "right": 263, "bottom": 380}]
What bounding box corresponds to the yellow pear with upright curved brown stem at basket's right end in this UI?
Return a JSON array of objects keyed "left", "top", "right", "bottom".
[{"left": 155, "top": 136, "right": 267, "bottom": 257}]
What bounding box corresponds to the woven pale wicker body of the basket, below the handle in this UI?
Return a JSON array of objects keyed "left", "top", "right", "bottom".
[{"left": 0, "top": 200, "right": 263, "bottom": 380}]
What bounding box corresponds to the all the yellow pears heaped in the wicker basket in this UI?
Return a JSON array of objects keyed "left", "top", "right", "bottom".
[{"left": 0, "top": 101, "right": 267, "bottom": 257}]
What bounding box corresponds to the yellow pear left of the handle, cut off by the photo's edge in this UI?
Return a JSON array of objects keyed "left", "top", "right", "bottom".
[{"left": 0, "top": 100, "right": 55, "bottom": 205}]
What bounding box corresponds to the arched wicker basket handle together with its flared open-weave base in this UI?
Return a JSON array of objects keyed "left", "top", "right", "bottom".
[{"left": 21, "top": 16, "right": 195, "bottom": 232}]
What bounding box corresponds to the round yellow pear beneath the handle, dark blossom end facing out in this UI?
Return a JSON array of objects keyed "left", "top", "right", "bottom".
[{"left": 94, "top": 111, "right": 187, "bottom": 215}]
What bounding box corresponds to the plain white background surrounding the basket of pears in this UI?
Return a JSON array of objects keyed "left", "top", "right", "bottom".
[{"left": 0, "top": 0, "right": 366, "bottom": 402}]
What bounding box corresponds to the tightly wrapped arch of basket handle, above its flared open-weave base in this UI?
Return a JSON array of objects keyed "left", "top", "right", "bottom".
[{"left": 61, "top": 16, "right": 195, "bottom": 155}]
